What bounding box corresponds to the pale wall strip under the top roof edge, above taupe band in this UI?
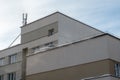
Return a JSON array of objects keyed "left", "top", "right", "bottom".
[{"left": 21, "top": 13, "right": 58, "bottom": 34}]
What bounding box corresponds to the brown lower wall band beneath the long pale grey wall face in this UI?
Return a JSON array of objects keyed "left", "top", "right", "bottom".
[{"left": 27, "top": 59, "right": 115, "bottom": 80}]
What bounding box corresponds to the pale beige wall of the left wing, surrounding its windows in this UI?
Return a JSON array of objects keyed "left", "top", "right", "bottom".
[{"left": 0, "top": 45, "right": 22, "bottom": 80}]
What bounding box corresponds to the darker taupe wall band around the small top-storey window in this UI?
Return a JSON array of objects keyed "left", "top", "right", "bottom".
[{"left": 21, "top": 22, "right": 58, "bottom": 43}]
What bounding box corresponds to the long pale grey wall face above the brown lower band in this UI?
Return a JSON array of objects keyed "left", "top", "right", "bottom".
[{"left": 27, "top": 34, "right": 109, "bottom": 75}]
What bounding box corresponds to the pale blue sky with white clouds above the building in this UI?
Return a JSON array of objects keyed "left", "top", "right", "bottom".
[{"left": 0, "top": 0, "right": 120, "bottom": 50}]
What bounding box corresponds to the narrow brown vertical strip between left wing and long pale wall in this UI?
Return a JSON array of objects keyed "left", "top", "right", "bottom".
[{"left": 21, "top": 48, "right": 28, "bottom": 80}]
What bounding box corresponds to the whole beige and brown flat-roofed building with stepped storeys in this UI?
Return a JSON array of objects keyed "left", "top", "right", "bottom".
[{"left": 0, "top": 12, "right": 120, "bottom": 80}]
